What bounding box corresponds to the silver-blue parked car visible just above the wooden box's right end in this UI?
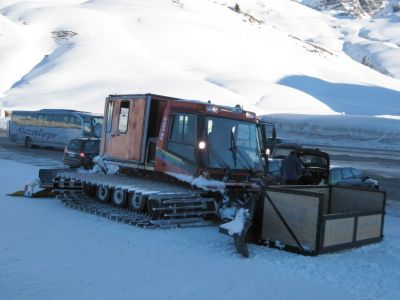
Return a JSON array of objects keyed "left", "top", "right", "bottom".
[{"left": 328, "top": 167, "right": 379, "bottom": 190}]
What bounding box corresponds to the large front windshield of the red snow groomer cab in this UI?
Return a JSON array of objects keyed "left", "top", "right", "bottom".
[{"left": 203, "top": 117, "right": 263, "bottom": 171}]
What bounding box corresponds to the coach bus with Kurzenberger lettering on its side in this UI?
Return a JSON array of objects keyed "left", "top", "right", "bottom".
[{"left": 8, "top": 109, "right": 103, "bottom": 149}]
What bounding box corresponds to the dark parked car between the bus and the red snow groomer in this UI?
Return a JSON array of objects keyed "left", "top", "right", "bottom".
[{"left": 63, "top": 138, "right": 100, "bottom": 169}]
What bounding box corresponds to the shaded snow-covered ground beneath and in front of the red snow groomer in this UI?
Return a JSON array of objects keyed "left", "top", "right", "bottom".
[{"left": 0, "top": 160, "right": 400, "bottom": 299}]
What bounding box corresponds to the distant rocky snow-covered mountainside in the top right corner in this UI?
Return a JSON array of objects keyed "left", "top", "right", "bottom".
[{"left": 298, "top": 0, "right": 400, "bottom": 79}]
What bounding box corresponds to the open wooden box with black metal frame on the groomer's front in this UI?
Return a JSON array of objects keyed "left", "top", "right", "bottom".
[{"left": 256, "top": 186, "right": 386, "bottom": 255}]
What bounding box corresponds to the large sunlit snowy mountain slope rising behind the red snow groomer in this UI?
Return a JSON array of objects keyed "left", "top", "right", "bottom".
[{"left": 0, "top": 0, "right": 400, "bottom": 115}]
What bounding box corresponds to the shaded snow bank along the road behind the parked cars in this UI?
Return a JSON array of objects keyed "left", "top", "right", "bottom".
[{"left": 263, "top": 115, "right": 400, "bottom": 150}]
